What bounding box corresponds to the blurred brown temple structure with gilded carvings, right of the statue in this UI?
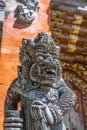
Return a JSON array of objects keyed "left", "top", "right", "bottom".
[{"left": 50, "top": 0, "right": 87, "bottom": 130}]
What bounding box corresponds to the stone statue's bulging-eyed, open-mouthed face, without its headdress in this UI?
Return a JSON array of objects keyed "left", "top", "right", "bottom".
[{"left": 30, "top": 45, "right": 58, "bottom": 86}]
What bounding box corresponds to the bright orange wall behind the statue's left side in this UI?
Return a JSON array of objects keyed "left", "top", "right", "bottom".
[{"left": 0, "top": 0, "right": 50, "bottom": 130}]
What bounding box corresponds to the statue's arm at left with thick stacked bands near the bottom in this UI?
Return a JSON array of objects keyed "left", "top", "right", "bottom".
[{"left": 4, "top": 83, "right": 23, "bottom": 130}]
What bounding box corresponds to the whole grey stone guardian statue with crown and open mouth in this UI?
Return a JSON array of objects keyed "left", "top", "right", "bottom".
[{"left": 4, "top": 32, "right": 76, "bottom": 130}]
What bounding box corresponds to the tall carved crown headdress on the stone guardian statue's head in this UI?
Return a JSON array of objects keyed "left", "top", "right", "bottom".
[{"left": 18, "top": 32, "right": 60, "bottom": 78}]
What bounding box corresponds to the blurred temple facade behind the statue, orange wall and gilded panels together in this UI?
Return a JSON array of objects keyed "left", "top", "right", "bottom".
[{"left": 0, "top": 0, "right": 87, "bottom": 130}]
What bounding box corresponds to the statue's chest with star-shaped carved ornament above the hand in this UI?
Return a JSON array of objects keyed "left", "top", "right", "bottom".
[{"left": 22, "top": 89, "right": 59, "bottom": 107}]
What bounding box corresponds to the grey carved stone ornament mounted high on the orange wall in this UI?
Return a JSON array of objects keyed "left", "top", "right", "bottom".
[{"left": 16, "top": 0, "right": 39, "bottom": 23}]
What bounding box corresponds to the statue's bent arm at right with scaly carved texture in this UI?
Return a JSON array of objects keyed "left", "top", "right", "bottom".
[{"left": 50, "top": 80, "right": 76, "bottom": 124}]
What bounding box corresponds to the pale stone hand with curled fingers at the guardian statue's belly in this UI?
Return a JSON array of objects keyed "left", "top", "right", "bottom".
[{"left": 31, "top": 100, "right": 54, "bottom": 124}]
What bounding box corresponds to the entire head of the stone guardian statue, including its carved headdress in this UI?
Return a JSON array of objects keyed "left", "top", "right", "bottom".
[{"left": 20, "top": 33, "right": 61, "bottom": 87}]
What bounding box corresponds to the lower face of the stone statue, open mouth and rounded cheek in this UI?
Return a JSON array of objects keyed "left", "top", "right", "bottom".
[{"left": 30, "top": 64, "right": 57, "bottom": 85}]
